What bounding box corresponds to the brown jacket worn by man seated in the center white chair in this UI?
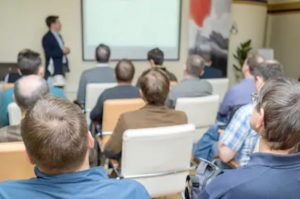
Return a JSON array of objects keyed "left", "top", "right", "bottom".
[{"left": 104, "top": 105, "right": 187, "bottom": 155}]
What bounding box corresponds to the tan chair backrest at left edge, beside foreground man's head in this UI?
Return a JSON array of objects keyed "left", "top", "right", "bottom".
[{"left": 0, "top": 142, "right": 35, "bottom": 182}]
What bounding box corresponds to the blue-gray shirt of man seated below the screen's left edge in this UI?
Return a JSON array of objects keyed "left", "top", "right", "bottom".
[{"left": 77, "top": 63, "right": 116, "bottom": 104}]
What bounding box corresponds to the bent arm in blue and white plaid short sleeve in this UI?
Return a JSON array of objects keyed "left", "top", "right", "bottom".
[{"left": 218, "top": 108, "right": 251, "bottom": 162}]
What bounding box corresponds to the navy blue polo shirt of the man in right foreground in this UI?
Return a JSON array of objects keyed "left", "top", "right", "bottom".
[{"left": 198, "top": 153, "right": 300, "bottom": 199}]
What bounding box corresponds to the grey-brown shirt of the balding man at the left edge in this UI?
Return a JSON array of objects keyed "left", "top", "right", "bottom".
[{"left": 0, "top": 125, "right": 22, "bottom": 142}]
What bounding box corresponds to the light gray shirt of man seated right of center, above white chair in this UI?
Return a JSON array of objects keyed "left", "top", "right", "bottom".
[{"left": 166, "top": 78, "right": 212, "bottom": 109}]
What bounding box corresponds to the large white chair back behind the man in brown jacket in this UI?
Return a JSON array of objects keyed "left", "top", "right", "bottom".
[{"left": 121, "top": 124, "right": 195, "bottom": 198}]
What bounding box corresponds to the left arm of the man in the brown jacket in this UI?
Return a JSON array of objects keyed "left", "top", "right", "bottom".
[{"left": 105, "top": 115, "right": 127, "bottom": 156}]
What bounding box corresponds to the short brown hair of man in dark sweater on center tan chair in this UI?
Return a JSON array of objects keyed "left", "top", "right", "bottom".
[{"left": 115, "top": 59, "right": 135, "bottom": 82}]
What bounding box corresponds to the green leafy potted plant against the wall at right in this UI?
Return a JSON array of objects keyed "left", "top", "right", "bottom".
[{"left": 233, "top": 39, "right": 252, "bottom": 82}]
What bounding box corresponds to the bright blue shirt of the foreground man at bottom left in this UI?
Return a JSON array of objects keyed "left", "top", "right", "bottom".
[{"left": 0, "top": 167, "right": 150, "bottom": 199}]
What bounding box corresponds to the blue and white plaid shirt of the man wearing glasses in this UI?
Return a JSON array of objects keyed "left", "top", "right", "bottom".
[{"left": 220, "top": 103, "right": 258, "bottom": 166}]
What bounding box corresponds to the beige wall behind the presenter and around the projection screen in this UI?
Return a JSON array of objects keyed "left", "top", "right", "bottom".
[{"left": 0, "top": 0, "right": 266, "bottom": 99}]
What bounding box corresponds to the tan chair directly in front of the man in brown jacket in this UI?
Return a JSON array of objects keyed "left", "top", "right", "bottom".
[{"left": 101, "top": 98, "right": 146, "bottom": 151}]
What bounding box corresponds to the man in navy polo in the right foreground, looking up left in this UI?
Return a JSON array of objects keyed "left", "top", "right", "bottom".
[{"left": 198, "top": 79, "right": 300, "bottom": 199}]
